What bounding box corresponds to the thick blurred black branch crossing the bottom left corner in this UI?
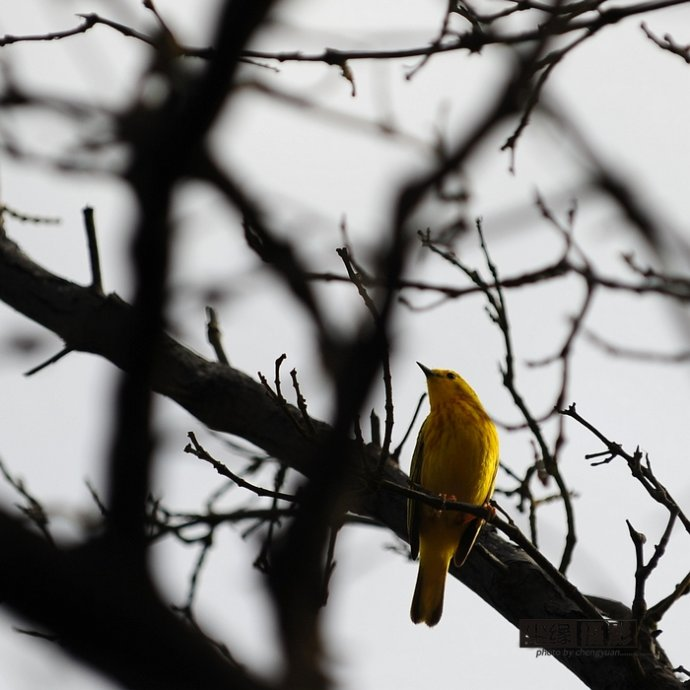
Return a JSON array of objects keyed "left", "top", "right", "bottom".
[{"left": 0, "top": 513, "right": 266, "bottom": 690}]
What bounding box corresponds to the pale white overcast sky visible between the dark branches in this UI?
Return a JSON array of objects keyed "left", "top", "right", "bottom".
[{"left": 0, "top": 0, "right": 690, "bottom": 690}]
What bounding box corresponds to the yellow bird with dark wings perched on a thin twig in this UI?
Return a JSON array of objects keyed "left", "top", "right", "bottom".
[{"left": 407, "top": 362, "right": 498, "bottom": 626}]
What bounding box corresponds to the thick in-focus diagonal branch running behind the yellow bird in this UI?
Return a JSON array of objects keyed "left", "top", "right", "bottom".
[{"left": 0, "top": 228, "right": 680, "bottom": 688}]
